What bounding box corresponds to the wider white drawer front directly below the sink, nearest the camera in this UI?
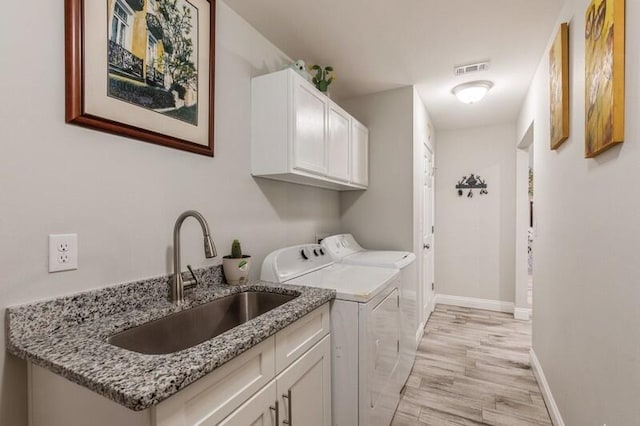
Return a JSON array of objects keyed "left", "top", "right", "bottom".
[{"left": 155, "top": 337, "right": 275, "bottom": 426}]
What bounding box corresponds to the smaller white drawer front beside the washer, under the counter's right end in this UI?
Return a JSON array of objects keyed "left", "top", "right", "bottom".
[{"left": 276, "top": 303, "right": 330, "bottom": 374}]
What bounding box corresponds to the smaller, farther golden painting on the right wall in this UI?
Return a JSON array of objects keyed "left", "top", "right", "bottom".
[{"left": 549, "top": 23, "right": 569, "bottom": 149}]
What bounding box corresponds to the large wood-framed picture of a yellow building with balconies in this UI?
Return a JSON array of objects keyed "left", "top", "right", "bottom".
[{"left": 65, "top": 0, "right": 215, "bottom": 156}]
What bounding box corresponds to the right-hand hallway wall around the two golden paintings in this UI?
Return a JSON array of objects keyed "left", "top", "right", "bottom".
[{"left": 518, "top": 0, "right": 640, "bottom": 426}]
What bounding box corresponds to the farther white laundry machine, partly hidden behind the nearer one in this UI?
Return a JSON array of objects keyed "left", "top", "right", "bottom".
[{"left": 322, "top": 234, "right": 422, "bottom": 386}]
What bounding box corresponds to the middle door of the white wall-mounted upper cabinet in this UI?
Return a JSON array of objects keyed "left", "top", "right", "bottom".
[{"left": 327, "top": 106, "right": 351, "bottom": 181}]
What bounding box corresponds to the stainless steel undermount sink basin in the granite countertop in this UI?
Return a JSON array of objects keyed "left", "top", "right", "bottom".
[{"left": 107, "top": 291, "right": 297, "bottom": 355}]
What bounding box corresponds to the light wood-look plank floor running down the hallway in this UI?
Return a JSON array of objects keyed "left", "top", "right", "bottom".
[{"left": 392, "top": 305, "right": 551, "bottom": 426}]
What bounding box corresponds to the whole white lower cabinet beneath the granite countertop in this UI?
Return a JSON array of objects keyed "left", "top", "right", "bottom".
[{"left": 29, "top": 303, "right": 331, "bottom": 426}]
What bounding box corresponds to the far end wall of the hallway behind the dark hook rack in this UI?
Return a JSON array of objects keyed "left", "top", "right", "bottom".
[{"left": 435, "top": 125, "right": 516, "bottom": 302}]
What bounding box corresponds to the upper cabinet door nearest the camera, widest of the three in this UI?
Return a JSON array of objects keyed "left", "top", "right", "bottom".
[{"left": 293, "top": 83, "right": 327, "bottom": 174}]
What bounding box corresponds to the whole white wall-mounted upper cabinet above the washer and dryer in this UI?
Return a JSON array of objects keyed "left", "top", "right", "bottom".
[{"left": 251, "top": 69, "right": 368, "bottom": 190}]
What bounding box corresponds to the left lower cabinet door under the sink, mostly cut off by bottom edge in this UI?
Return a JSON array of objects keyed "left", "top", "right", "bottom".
[{"left": 218, "top": 381, "right": 278, "bottom": 426}]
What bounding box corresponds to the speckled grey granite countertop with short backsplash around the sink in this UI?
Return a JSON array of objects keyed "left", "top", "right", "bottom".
[{"left": 5, "top": 266, "right": 335, "bottom": 410}]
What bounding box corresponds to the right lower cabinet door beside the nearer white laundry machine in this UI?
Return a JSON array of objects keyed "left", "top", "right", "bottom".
[{"left": 276, "top": 336, "right": 331, "bottom": 426}]
